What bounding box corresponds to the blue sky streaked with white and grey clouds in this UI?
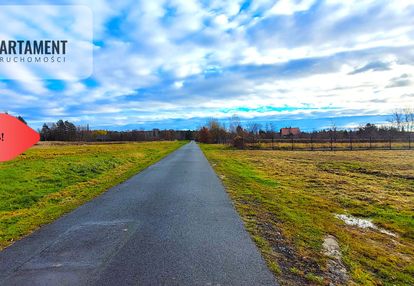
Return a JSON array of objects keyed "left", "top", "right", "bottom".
[{"left": 0, "top": 0, "right": 414, "bottom": 130}]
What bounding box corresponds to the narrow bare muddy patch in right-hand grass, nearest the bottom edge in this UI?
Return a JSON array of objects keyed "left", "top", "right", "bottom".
[{"left": 322, "top": 235, "right": 349, "bottom": 285}]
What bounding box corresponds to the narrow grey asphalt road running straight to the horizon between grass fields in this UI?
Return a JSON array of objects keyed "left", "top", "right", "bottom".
[{"left": 0, "top": 143, "right": 276, "bottom": 286}]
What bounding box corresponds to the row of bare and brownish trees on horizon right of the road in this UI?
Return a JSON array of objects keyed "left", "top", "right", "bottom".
[{"left": 196, "top": 108, "right": 414, "bottom": 148}]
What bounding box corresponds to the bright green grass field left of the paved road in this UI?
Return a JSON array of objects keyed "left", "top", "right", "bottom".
[{"left": 0, "top": 141, "right": 185, "bottom": 249}]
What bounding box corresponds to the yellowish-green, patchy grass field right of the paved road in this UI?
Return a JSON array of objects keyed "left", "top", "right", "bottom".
[{"left": 202, "top": 145, "right": 414, "bottom": 285}]
